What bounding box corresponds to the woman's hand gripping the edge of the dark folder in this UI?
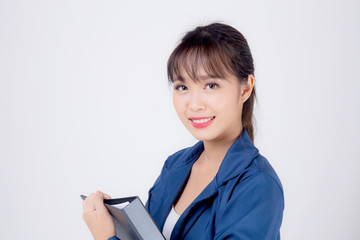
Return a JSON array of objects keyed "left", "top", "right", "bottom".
[{"left": 83, "top": 191, "right": 116, "bottom": 240}]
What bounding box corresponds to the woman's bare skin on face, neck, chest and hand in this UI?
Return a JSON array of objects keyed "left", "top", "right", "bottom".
[{"left": 83, "top": 66, "right": 255, "bottom": 240}]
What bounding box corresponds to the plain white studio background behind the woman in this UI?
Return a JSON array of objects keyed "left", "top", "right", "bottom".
[{"left": 0, "top": 0, "right": 360, "bottom": 240}]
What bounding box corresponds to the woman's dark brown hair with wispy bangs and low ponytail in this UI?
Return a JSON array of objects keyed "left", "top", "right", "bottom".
[{"left": 167, "top": 23, "right": 255, "bottom": 142}]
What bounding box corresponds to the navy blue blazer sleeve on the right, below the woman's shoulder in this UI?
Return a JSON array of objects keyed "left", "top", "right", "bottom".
[{"left": 214, "top": 173, "right": 284, "bottom": 240}]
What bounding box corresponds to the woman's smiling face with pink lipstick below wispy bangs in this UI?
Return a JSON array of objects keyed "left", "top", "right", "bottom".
[{"left": 173, "top": 66, "right": 252, "bottom": 142}]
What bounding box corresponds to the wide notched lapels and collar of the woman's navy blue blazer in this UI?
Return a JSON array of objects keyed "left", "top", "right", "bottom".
[{"left": 158, "top": 129, "right": 258, "bottom": 229}]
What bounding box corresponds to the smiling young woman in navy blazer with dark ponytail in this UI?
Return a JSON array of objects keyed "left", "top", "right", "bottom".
[{"left": 83, "top": 23, "right": 284, "bottom": 240}]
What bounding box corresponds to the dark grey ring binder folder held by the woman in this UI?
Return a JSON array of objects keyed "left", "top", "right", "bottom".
[{"left": 81, "top": 195, "right": 165, "bottom": 240}]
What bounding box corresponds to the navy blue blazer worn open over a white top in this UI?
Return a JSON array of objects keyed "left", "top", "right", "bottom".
[{"left": 108, "top": 129, "right": 284, "bottom": 240}]
